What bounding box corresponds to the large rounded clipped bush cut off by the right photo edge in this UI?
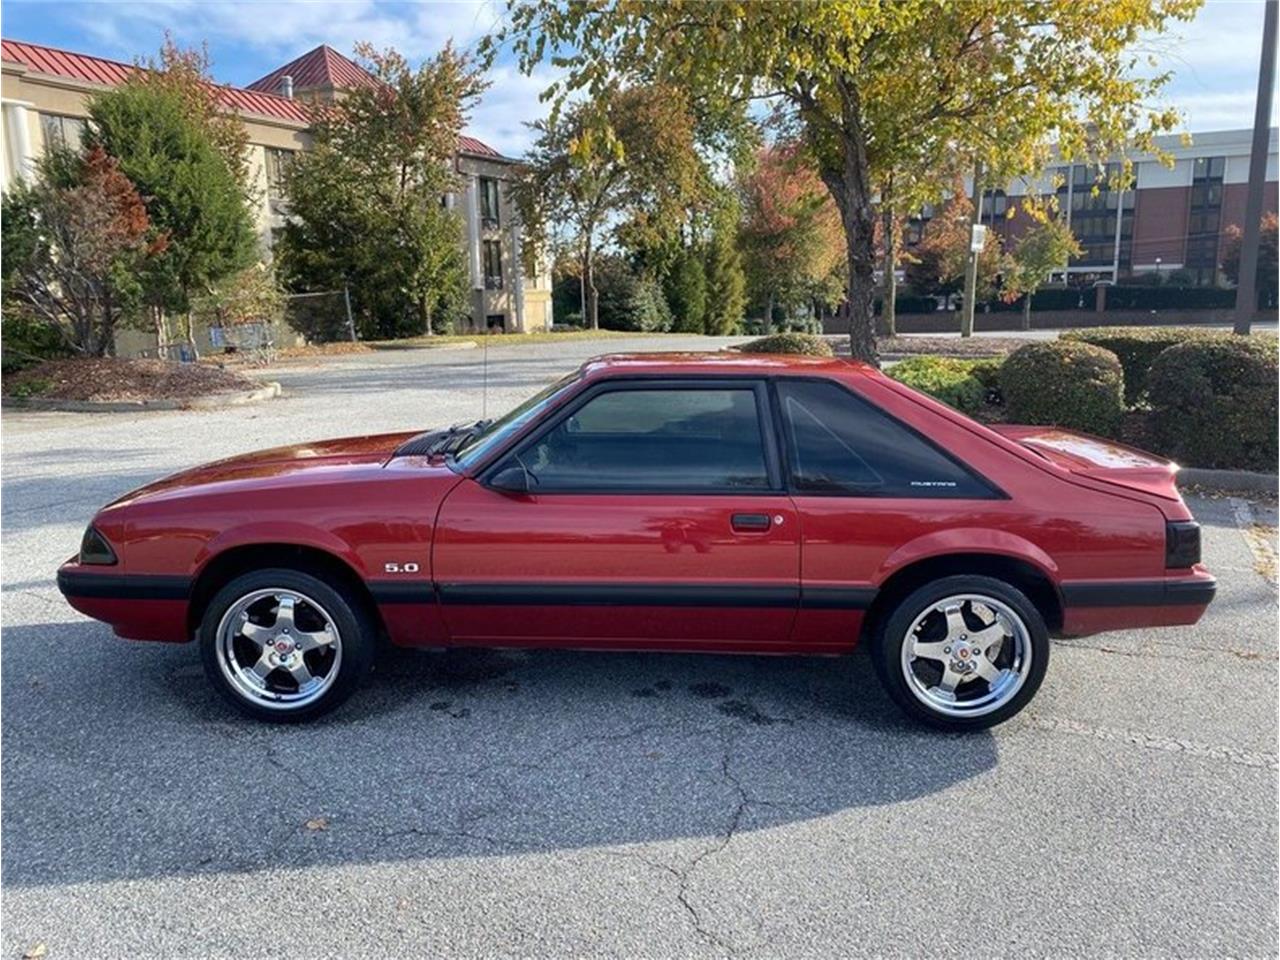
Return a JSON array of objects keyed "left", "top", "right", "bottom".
[{"left": 1147, "top": 334, "right": 1277, "bottom": 474}]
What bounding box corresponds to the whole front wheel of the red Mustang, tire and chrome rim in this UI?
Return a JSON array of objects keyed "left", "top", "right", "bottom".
[{"left": 200, "top": 568, "right": 375, "bottom": 722}]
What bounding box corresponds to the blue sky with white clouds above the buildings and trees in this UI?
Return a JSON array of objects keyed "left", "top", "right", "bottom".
[{"left": 0, "top": 0, "right": 1262, "bottom": 156}]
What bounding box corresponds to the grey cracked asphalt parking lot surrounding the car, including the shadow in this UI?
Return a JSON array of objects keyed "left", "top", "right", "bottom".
[{"left": 0, "top": 338, "right": 1280, "bottom": 959}]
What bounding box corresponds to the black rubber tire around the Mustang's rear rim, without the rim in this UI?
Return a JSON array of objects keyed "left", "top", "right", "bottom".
[{"left": 870, "top": 576, "right": 1050, "bottom": 731}]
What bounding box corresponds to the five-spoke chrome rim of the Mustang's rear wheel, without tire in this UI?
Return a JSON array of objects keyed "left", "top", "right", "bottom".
[{"left": 902, "top": 594, "right": 1032, "bottom": 717}]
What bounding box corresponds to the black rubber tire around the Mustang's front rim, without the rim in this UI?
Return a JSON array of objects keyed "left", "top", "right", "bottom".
[{"left": 197, "top": 567, "right": 378, "bottom": 723}]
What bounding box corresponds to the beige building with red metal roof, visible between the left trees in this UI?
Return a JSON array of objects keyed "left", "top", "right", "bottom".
[{"left": 0, "top": 40, "right": 552, "bottom": 353}]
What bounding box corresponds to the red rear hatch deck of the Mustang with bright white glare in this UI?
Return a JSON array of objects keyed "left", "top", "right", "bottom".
[{"left": 991, "top": 424, "right": 1180, "bottom": 500}]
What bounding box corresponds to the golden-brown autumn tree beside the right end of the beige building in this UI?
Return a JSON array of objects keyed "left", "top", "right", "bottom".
[{"left": 517, "top": 84, "right": 705, "bottom": 329}]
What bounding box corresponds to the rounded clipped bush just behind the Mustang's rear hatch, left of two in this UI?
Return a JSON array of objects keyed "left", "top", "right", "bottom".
[{"left": 1000, "top": 340, "right": 1124, "bottom": 436}]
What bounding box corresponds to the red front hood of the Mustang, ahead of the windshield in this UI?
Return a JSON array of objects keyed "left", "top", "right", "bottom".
[{"left": 109, "top": 433, "right": 415, "bottom": 507}]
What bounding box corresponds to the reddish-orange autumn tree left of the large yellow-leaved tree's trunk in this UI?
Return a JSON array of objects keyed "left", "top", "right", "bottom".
[{"left": 741, "top": 143, "right": 844, "bottom": 333}]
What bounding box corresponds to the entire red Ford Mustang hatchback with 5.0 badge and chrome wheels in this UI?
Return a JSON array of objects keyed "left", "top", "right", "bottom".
[{"left": 58, "top": 353, "right": 1215, "bottom": 728}]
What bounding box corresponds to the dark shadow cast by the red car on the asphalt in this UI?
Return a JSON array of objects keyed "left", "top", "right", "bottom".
[{"left": 0, "top": 621, "right": 997, "bottom": 886}]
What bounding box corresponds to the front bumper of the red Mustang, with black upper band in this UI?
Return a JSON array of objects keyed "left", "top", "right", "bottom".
[{"left": 58, "top": 559, "right": 191, "bottom": 643}]
